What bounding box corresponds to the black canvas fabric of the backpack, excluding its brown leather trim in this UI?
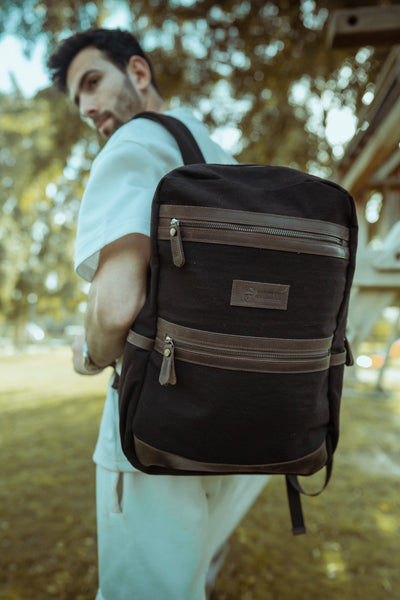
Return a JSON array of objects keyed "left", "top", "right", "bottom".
[{"left": 119, "top": 113, "right": 357, "bottom": 488}]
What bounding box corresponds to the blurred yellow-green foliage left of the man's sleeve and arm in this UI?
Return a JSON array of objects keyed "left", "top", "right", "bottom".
[{"left": 0, "top": 90, "right": 94, "bottom": 339}]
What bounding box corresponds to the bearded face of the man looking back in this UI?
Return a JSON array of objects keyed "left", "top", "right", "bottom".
[{"left": 67, "top": 47, "right": 144, "bottom": 138}]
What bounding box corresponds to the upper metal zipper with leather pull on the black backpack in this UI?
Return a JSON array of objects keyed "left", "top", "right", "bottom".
[{"left": 169, "top": 213, "right": 348, "bottom": 267}]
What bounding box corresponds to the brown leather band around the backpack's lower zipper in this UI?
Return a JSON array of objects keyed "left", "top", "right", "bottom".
[{"left": 155, "top": 318, "right": 332, "bottom": 373}]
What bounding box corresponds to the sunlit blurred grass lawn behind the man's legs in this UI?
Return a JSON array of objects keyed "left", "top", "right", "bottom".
[{"left": 0, "top": 349, "right": 400, "bottom": 600}]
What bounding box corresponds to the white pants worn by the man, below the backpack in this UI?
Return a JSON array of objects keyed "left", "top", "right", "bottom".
[{"left": 96, "top": 466, "right": 268, "bottom": 600}]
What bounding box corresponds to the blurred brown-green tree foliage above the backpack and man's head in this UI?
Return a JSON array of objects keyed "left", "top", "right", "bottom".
[{"left": 0, "top": 0, "right": 388, "bottom": 168}]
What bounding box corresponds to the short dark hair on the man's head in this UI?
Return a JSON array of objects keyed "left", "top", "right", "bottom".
[{"left": 47, "top": 29, "right": 158, "bottom": 92}]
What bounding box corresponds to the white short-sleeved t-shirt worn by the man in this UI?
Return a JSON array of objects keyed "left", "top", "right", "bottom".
[{"left": 75, "top": 108, "right": 235, "bottom": 471}]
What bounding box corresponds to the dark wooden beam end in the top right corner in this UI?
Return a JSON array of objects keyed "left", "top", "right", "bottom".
[{"left": 328, "top": 5, "right": 400, "bottom": 48}]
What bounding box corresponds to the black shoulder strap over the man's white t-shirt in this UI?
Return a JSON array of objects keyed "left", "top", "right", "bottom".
[{"left": 133, "top": 111, "right": 206, "bottom": 165}]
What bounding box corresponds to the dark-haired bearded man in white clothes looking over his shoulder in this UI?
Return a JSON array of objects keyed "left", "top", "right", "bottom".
[{"left": 49, "top": 29, "right": 266, "bottom": 600}]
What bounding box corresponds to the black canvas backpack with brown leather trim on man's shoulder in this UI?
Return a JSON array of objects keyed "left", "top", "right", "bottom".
[{"left": 119, "top": 113, "right": 357, "bottom": 533}]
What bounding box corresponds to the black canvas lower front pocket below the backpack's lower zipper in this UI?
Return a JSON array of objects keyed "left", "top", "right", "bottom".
[{"left": 131, "top": 350, "right": 329, "bottom": 473}]
